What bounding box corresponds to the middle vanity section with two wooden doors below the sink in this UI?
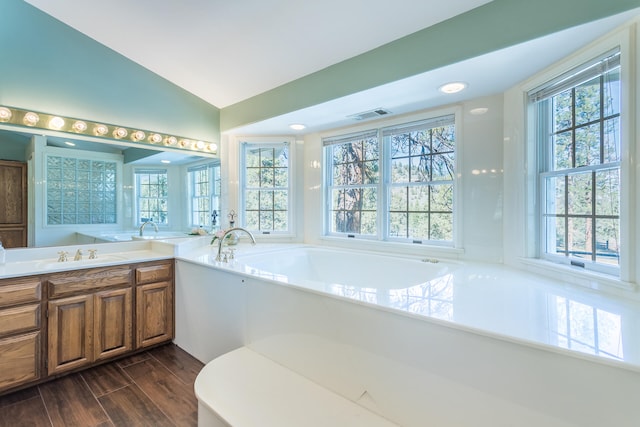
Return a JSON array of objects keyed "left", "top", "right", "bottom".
[{"left": 47, "top": 266, "right": 133, "bottom": 375}]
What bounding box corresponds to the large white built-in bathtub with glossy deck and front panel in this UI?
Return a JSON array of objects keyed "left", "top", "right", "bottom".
[{"left": 176, "top": 245, "right": 640, "bottom": 427}]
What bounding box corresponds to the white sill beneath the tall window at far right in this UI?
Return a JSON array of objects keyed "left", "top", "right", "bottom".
[{"left": 519, "top": 258, "right": 638, "bottom": 292}]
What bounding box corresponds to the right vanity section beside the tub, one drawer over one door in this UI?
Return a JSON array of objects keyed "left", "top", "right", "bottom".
[{"left": 136, "top": 261, "right": 174, "bottom": 348}]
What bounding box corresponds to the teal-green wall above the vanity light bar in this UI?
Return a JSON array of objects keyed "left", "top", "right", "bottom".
[{"left": 0, "top": 0, "right": 220, "bottom": 142}]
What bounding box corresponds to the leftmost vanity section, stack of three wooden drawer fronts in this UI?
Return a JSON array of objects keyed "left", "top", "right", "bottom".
[{"left": 0, "top": 277, "right": 42, "bottom": 390}]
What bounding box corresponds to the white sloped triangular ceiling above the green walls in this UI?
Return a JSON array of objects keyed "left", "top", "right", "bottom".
[{"left": 26, "top": 0, "right": 489, "bottom": 108}]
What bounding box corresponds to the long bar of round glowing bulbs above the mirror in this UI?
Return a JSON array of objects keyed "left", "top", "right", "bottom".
[{"left": 0, "top": 105, "right": 218, "bottom": 154}]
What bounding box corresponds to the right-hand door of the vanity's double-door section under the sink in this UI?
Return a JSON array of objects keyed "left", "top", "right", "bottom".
[{"left": 93, "top": 288, "right": 133, "bottom": 360}]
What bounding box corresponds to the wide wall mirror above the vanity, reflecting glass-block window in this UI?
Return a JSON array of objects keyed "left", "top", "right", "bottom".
[{"left": 0, "top": 128, "right": 220, "bottom": 247}]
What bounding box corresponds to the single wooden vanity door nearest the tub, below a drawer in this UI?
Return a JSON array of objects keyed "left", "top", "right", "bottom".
[{"left": 136, "top": 282, "right": 173, "bottom": 348}]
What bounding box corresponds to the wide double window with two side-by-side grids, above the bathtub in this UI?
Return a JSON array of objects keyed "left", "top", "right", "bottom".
[{"left": 323, "top": 115, "right": 455, "bottom": 245}]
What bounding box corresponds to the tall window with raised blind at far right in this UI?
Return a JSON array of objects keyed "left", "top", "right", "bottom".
[{"left": 530, "top": 52, "right": 621, "bottom": 273}]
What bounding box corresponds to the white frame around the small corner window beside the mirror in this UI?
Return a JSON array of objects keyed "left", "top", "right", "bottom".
[{"left": 238, "top": 137, "right": 296, "bottom": 239}]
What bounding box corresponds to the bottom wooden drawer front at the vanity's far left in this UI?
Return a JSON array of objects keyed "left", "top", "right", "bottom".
[{"left": 0, "top": 331, "right": 40, "bottom": 390}]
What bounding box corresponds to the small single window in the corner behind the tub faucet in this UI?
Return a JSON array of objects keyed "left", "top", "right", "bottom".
[{"left": 241, "top": 142, "right": 291, "bottom": 234}]
